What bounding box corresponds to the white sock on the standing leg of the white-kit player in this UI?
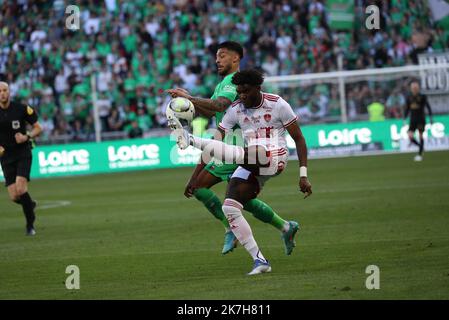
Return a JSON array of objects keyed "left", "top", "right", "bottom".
[{"left": 222, "top": 199, "right": 266, "bottom": 261}]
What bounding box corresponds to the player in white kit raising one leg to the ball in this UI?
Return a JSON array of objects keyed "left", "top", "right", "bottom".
[{"left": 170, "top": 70, "right": 312, "bottom": 275}]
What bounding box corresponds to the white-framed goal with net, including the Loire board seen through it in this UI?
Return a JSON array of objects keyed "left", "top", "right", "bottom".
[{"left": 263, "top": 54, "right": 449, "bottom": 158}]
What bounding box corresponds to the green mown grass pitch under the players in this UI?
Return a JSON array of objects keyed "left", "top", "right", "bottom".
[{"left": 0, "top": 152, "right": 449, "bottom": 299}]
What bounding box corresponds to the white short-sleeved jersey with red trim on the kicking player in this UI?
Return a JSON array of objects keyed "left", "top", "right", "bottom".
[{"left": 219, "top": 93, "right": 297, "bottom": 150}]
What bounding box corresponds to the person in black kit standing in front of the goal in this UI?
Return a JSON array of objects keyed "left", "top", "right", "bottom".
[{"left": 404, "top": 80, "right": 433, "bottom": 161}]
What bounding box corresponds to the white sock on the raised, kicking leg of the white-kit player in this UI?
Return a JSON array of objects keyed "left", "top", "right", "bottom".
[{"left": 190, "top": 135, "right": 245, "bottom": 164}]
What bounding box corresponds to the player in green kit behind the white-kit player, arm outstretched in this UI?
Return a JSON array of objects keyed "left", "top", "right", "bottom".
[{"left": 167, "top": 41, "right": 299, "bottom": 255}]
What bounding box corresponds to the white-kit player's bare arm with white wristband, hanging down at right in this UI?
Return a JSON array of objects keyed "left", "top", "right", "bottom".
[{"left": 286, "top": 121, "right": 312, "bottom": 198}]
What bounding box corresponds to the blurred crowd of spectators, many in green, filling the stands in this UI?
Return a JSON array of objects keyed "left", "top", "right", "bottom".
[{"left": 0, "top": 0, "right": 449, "bottom": 141}]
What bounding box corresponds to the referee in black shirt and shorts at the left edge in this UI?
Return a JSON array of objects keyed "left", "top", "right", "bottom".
[{"left": 0, "top": 82, "right": 42, "bottom": 236}]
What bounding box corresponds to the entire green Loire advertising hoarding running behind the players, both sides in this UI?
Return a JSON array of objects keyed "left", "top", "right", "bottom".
[{"left": 0, "top": 116, "right": 449, "bottom": 180}]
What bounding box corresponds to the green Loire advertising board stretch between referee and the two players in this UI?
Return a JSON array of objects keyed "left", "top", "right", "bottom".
[{"left": 0, "top": 136, "right": 200, "bottom": 179}]
